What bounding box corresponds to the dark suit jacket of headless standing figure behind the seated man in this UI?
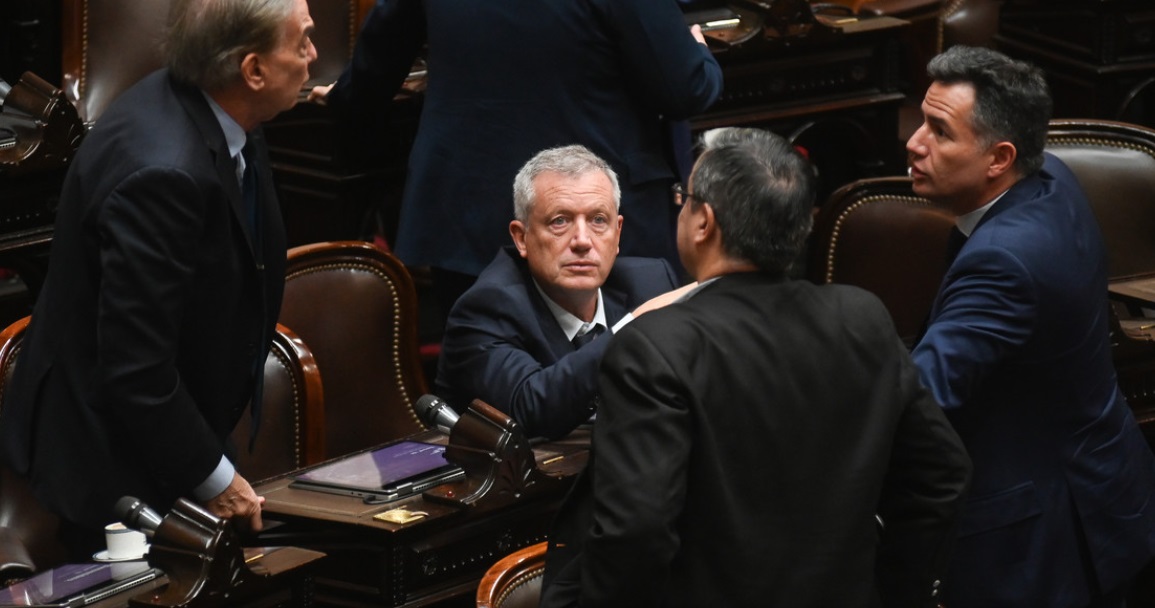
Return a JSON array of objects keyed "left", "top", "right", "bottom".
[{"left": 329, "top": 0, "right": 722, "bottom": 276}]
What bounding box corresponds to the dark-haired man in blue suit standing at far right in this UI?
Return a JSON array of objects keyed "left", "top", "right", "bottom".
[{"left": 907, "top": 47, "right": 1155, "bottom": 608}]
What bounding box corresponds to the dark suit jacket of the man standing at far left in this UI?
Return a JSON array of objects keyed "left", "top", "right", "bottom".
[{"left": 0, "top": 71, "right": 285, "bottom": 526}]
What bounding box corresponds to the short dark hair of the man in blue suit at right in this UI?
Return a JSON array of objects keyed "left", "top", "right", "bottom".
[{"left": 926, "top": 46, "right": 1052, "bottom": 176}]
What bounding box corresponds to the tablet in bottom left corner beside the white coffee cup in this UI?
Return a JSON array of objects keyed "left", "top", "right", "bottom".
[{"left": 0, "top": 559, "right": 161, "bottom": 607}]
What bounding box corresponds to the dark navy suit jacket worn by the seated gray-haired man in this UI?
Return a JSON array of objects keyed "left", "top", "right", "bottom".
[{"left": 437, "top": 247, "right": 678, "bottom": 438}]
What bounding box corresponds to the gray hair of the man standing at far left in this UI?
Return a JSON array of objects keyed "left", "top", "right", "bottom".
[{"left": 164, "top": 0, "right": 296, "bottom": 91}]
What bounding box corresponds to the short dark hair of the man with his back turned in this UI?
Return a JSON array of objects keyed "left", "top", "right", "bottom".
[{"left": 687, "top": 127, "right": 815, "bottom": 273}]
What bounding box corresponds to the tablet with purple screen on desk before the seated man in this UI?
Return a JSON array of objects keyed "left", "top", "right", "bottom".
[{"left": 290, "top": 440, "right": 465, "bottom": 503}]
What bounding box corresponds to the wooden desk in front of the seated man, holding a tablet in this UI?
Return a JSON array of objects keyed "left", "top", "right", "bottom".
[{"left": 255, "top": 430, "right": 589, "bottom": 607}]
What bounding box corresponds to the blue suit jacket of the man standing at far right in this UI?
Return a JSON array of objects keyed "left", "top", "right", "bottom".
[{"left": 914, "top": 155, "right": 1155, "bottom": 608}]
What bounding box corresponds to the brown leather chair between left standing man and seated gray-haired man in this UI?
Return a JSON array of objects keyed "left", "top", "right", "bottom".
[{"left": 281, "top": 240, "right": 426, "bottom": 458}]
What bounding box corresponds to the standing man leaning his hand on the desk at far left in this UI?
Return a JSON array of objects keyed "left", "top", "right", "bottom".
[{"left": 0, "top": 0, "right": 316, "bottom": 553}]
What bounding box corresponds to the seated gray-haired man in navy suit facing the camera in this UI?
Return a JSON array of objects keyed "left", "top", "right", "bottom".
[{"left": 437, "top": 146, "right": 677, "bottom": 438}]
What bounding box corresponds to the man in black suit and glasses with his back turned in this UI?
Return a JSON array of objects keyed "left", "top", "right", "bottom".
[{"left": 543, "top": 129, "right": 970, "bottom": 608}]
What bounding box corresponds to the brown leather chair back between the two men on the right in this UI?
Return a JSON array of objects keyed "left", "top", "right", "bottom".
[{"left": 807, "top": 177, "right": 954, "bottom": 344}]
